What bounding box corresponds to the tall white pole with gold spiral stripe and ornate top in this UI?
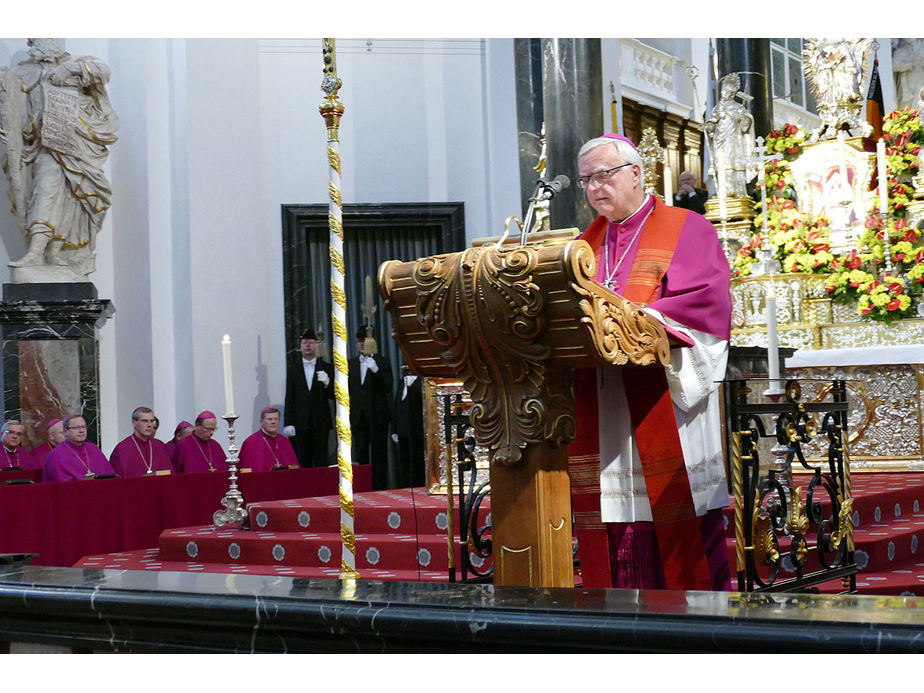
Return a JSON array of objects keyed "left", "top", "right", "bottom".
[{"left": 318, "top": 39, "right": 359, "bottom": 579}]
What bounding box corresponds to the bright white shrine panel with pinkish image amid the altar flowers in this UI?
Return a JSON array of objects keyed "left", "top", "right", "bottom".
[{"left": 790, "top": 137, "right": 875, "bottom": 255}]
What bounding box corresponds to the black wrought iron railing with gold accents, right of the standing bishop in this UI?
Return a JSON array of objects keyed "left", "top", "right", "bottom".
[{"left": 725, "top": 380, "right": 857, "bottom": 592}]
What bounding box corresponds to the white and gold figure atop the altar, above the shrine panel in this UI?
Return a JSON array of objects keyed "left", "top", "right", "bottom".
[{"left": 802, "top": 38, "right": 872, "bottom": 141}]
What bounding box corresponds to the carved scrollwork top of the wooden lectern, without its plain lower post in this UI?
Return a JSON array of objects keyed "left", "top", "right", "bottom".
[{"left": 379, "top": 241, "right": 669, "bottom": 465}]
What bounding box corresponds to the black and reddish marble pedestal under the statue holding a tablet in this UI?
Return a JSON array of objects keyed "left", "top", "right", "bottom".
[{"left": 0, "top": 283, "right": 115, "bottom": 446}]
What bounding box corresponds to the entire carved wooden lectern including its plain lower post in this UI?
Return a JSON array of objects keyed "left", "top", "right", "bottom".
[{"left": 379, "top": 240, "right": 670, "bottom": 587}]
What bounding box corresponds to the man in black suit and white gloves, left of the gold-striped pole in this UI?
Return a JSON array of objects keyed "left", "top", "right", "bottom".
[{"left": 285, "top": 329, "right": 334, "bottom": 467}]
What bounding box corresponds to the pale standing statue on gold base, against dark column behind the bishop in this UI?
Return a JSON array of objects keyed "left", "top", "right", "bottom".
[{"left": 703, "top": 72, "right": 757, "bottom": 197}]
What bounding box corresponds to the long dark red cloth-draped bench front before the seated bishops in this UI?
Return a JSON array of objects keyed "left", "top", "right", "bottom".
[{"left": 0, "top": 465, "right": 372, "bottom": 566}]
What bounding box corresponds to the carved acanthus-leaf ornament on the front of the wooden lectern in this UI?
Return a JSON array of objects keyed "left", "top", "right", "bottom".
[{"left": 413, "top": 246, "right": 560, "bottom": 465}]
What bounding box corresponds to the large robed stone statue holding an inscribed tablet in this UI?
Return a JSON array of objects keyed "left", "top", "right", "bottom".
[{"left": 0, "top": 39, "right": 119, "bottom": 283}]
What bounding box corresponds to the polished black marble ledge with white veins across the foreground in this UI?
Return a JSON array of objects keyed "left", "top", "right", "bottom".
[{"left": 0, "top": 565, "right": 924, "bottom": 653}]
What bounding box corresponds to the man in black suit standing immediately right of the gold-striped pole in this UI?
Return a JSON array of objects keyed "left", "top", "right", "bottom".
[{"left": 348, "top": 326, "right": 392, "bottom": 491}]
